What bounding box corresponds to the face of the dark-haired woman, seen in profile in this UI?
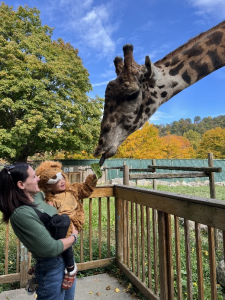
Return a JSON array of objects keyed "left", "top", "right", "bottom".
[{"left": 19, "top": 166, "right": 40, "bottom": 198}]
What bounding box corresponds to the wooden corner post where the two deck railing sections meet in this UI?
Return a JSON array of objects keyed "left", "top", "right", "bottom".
[{"left": 115, "top": 198, "right": 123, "bottom": 262}]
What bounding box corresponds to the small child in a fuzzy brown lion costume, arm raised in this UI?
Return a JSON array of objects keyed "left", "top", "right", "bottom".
[{"left": 36, "top": 161, "right": 97, "bottom": 289}]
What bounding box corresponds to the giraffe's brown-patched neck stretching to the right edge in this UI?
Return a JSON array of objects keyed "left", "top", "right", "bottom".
[{"left": 155, "top": 22, "right": 225, "bottom": 105}]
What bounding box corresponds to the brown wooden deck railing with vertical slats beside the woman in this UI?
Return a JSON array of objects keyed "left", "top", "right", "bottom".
[{"left": 0, "top": 185, "right": 225, "bottom": 300}]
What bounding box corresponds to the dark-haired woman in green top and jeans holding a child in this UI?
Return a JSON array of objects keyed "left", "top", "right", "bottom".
[{"left": 0, "top": 163, "right": 78, "bottom": 300}]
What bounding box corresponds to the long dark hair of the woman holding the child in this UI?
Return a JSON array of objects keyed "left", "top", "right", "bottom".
[{"left": 0, "top": 163, "right": 35, "bottom": 223}]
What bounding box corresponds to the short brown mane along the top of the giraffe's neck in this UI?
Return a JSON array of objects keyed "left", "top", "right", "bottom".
[{"left": 155, "top": 21, "right": 225, "bottom": 66}]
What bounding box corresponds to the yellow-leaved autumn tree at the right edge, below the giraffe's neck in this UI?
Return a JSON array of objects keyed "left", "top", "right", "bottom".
[{"left": 197, "top": 127, "right": 225, "bottom": 159}]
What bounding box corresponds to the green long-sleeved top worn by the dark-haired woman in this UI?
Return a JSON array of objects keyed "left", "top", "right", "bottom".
[{"left": 10, "top": 192, "right": 63, "bottom": 258}]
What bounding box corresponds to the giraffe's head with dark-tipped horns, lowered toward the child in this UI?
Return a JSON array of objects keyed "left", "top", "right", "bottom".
[{"left": 94, "top": 44, "right": 158, "bottom": 158}]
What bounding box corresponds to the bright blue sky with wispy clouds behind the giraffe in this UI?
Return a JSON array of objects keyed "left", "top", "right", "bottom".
[{"left": 4, "top": 0, "right": 225, "bottom": 124}]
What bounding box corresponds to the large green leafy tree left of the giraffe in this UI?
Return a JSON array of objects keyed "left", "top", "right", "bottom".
[{"left": 0, "top": 3, "right": 103, "bottom": 161}]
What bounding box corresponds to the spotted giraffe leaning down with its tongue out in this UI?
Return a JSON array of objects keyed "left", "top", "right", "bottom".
[{"left": 94, "top": 21, "right": 225, "bottom": 164}]
